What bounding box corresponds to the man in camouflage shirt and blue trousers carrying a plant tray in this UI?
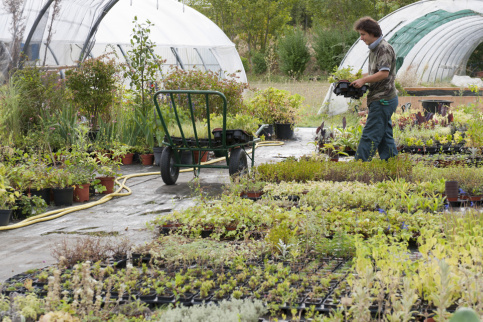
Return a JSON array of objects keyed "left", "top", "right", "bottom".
[{"left": 351, "top": 17, "right": 398, "bottom": 161}]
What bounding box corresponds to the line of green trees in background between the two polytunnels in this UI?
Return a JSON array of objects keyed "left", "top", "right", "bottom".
[{"left": 185, "top": 0, "right": 417, "bottom": 76}]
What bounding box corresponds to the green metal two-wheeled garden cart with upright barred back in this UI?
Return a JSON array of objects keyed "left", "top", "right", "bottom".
[{"left": 154, "top": 90, "right": 260, "bottom": 185}]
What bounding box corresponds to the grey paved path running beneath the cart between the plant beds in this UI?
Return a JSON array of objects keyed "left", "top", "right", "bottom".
[{"left": 0, "top": 128, "right": 315, "bottom": 282}]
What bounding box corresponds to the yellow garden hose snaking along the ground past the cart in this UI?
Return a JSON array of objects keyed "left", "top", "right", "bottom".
[{"left": 0, "top": 141, "right": 284, "bottom": 231}]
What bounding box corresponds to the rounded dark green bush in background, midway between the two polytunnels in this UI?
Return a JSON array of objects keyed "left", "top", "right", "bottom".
[{"left": 278, "top": 29, "right": 310, "bottom": 79}]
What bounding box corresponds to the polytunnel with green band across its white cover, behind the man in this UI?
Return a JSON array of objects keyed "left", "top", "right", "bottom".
[{"left": 320, "top": 0, "right": 483, "bottom": 114}]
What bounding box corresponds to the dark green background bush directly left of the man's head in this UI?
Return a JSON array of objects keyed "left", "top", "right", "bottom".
[{"left": 313, "top": 27, "right": 359, "bottom": 71}]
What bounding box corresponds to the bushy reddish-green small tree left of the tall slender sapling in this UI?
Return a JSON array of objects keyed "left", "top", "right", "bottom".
[{"left": 67, "top": 56, "right": 118, "bottom": 129}]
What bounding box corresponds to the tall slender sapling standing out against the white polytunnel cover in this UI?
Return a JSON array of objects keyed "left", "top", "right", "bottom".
[{"left": 124, "top": 16, "right": 162, "bottom": 114}]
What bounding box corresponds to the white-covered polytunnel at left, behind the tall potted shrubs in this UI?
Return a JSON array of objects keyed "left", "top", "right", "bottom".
[{"left": 0, "top": 0, "right": 247, "bottom": 82}]
